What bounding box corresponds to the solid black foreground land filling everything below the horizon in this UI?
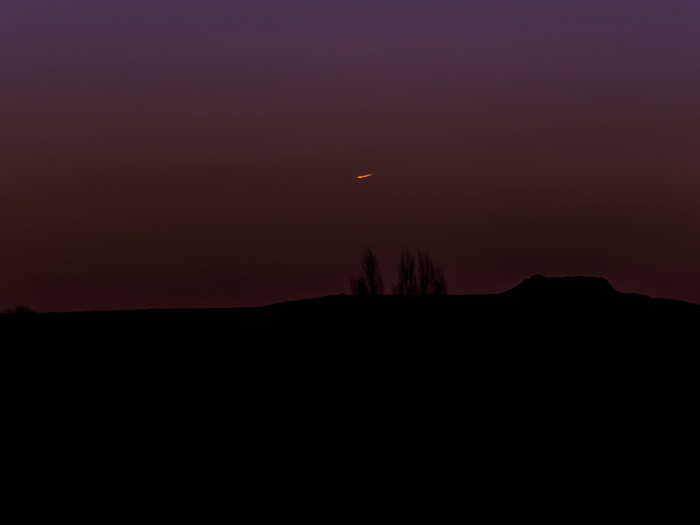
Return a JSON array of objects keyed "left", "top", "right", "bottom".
[{"left": 0, "top": 276, "right": 700, "bottom": 512}]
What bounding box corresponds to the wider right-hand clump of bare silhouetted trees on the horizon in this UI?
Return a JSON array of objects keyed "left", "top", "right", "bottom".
[{"left": 394, "top": 250, "right": 447, "bottom": 296}]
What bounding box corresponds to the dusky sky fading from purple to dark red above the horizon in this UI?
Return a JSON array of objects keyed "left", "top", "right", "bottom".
[{"left": 0, "top": 0, "right": 700, "bottom": 311}]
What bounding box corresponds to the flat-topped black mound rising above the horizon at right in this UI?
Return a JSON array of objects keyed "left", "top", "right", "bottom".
[{"left": 506, "top": 275, "right": 619, "bottom": 301}]
